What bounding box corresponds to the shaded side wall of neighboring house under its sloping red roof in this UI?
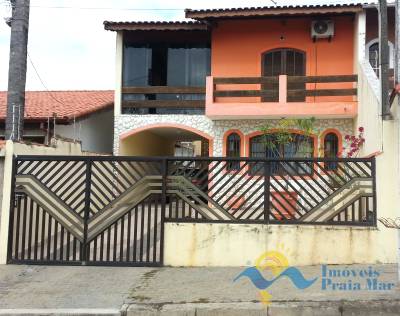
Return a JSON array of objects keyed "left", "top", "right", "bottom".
[{"left": 56, "top": 109, "right": 114, "bottom": 153}]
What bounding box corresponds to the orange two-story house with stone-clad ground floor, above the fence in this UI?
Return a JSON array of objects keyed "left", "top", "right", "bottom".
[{"left": 105, "top": 5, "right": 394, "bottom": 157}]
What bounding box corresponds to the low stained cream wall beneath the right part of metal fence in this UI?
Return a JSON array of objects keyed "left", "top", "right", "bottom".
[{"left": 164, "top": 223, "right": 397, "bottom": 266}]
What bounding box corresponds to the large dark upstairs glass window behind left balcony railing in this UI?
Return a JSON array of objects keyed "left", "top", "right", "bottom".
[{"left": 122, "top": 43, "right": 211, "bottom": 114}]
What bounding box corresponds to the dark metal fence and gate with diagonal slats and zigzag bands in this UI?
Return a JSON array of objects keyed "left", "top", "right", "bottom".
[{"left": 8, "top": 156, "right": 376, "bottom": 266}]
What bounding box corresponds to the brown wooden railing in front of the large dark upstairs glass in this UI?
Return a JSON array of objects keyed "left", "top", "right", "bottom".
[{"left": 122, "top": 86, "right": 206, "bottom": 108}]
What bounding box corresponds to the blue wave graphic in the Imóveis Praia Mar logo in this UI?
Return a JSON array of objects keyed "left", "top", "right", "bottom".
[{"left": 233, "top": 267, "right": 318, "bottom": 290}]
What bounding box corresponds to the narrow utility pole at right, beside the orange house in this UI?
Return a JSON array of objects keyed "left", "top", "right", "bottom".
[{"left": 378, "top": 0, "right": 392, "bottom": 120}]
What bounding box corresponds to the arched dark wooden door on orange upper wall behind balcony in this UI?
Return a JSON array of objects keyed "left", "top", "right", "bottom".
[{"left": 261, "top": 48, "right": 306, "bottom": 102}]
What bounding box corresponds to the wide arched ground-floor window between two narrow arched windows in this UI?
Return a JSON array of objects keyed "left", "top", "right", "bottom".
[{"left": 250, "top": 133, "right": 314, "bottom": 175}]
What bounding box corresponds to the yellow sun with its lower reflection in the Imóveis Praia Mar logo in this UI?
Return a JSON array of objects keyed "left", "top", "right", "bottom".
[{"left": 255, "top": 244, "right": 289, "bottom": 305}]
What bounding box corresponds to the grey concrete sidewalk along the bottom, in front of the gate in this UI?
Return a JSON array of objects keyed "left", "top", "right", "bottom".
[{"left": 0, "top": 265, "right": 400, "bottom": 316}]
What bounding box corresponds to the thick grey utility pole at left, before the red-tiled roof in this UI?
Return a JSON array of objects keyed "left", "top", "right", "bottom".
[{"left": 5, "top": 0, "right": 30, "bottom": 141}]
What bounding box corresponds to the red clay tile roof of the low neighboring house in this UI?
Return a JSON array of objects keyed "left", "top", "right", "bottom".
[{"left": 0, "top": 90, "right": 114, "bottom": 120}]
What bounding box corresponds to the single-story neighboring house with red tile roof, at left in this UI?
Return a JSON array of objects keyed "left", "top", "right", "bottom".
[{"left": 0, "top": 91, "right": 114, "bottom": 153}]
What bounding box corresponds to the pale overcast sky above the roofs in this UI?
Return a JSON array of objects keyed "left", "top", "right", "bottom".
[{"left": 0, "top": 0, "right": 376, "bottom": 91}]
